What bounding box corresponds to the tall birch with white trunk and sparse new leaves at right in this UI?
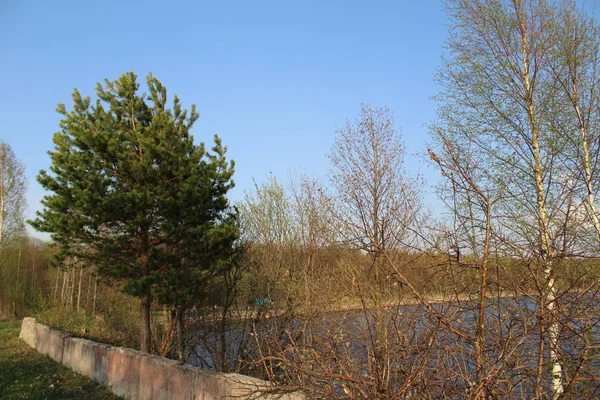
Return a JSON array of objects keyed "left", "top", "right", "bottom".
[{"left": 436, "top": 0, "right": 597, "bottom": 398}]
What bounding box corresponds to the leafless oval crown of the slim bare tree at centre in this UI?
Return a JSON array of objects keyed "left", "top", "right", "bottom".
[{"left": 329, "top": 105, "right": 420, "bottom": 260}]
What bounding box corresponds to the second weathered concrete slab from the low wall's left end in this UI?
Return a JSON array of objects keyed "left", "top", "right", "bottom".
[{"left": 62, "top": 337, "right": 111, "bottom": 386}]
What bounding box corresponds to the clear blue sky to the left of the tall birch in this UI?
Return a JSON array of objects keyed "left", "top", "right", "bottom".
[{"left": 0, "top": 0, "right": 447, "bottom": 238}]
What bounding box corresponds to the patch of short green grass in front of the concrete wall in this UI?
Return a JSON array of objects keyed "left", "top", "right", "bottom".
[{"left": 0, "top": 321, "right": 119, "bottom": 400}]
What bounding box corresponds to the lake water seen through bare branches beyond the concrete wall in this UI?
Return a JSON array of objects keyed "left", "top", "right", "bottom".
[{"left": 189, "top": 294, "right": 600, "bottom": 398}]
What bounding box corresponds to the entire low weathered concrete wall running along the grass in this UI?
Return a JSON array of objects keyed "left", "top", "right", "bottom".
[{"left": 19, "top": 318, "right": 305, "bottom": 400}]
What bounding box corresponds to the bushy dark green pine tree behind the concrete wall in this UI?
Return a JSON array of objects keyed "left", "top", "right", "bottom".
[{"left": 31, "top": 72, "right": 237, "bottom": 352}]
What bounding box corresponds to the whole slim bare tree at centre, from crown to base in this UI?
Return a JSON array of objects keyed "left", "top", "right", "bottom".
[{"left": 327, "top": 105, "right": 421, "bottom": 393}]
